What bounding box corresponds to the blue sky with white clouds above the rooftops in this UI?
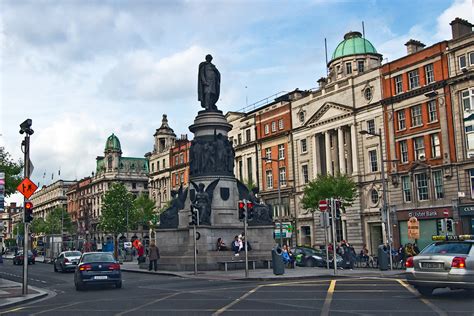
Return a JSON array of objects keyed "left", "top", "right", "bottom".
[{"left": 0, "top": 0, "right": 473, "bottom": 202}]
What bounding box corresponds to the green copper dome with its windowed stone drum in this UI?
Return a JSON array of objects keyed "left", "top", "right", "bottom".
[{"left": 328, "top": 32, "right": 382, "bottom": 82}]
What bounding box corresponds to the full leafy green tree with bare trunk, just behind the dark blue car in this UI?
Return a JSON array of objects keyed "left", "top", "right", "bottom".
[{"left": 99, "top": 183, "right": 137, "bottom": 258}]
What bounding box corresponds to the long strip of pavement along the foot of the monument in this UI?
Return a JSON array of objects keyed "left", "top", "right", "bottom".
[{"left": 121, "top": 262, "right": 405, "bottom": 281}]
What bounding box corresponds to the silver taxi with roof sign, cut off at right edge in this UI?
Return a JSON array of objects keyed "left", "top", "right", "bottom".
[{"left": 405, "top": 235, "right": 474, "bottom": 296}]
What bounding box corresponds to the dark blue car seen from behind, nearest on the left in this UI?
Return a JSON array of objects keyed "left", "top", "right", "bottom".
[{"left": 74, "top": 252, "right": 122, "bottom": 291}]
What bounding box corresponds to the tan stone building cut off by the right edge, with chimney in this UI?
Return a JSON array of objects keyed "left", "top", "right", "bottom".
[{"left": 445, "top": 18, "right": 474, "bottom": 234}]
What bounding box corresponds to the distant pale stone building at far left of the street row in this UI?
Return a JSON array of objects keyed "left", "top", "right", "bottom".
[{"left": 30, "top": 180, "right": 76, "bottom": 219}]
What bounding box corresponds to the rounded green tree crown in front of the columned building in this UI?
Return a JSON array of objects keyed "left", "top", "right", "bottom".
[{"left": 301, "top": 174, "right": 357, "bottom": 211}]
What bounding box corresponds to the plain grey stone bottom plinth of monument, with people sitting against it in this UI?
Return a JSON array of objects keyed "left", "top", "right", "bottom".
[{"left": 156, "top": 225, "right": 275, "bottom": 271}]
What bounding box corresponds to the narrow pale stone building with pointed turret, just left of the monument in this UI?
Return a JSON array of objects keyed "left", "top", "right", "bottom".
[{"left": 145, "top": 114, "right": 176, "bottom": 210}]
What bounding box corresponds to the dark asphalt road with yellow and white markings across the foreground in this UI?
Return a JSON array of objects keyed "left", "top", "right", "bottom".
[{"left": 0, "top": 261, "right": 474, "bottom": 316}]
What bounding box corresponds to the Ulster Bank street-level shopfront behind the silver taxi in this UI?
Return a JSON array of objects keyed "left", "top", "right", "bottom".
[{"left": 397, "top": 207, "right": 454, "bottom": 250}]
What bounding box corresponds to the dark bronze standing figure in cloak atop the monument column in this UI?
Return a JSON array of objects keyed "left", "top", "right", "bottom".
[{"left": 198, "top": 55, "right": 221, "bottom": 111}]
